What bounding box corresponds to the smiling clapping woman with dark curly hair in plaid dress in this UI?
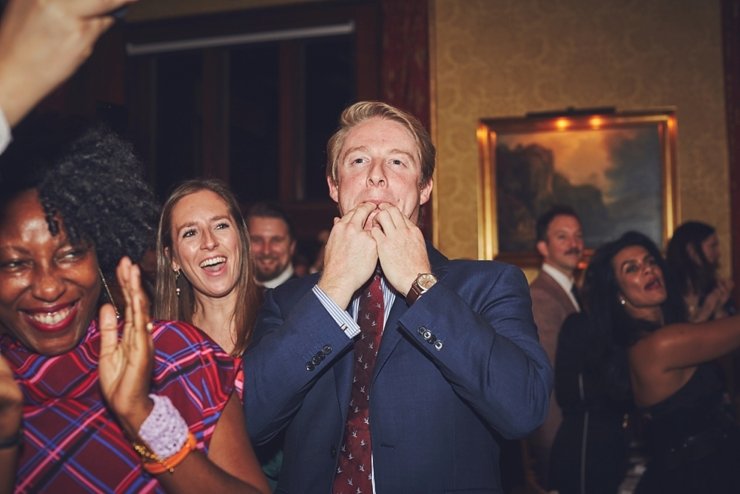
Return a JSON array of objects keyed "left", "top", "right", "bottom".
[{"left": 0, "top": 122, "right": 268, "bottom": 492}]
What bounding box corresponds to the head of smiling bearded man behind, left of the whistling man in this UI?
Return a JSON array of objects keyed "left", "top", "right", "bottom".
[{"left": 247, "top": 202, "right": 296, "bottom": 288}]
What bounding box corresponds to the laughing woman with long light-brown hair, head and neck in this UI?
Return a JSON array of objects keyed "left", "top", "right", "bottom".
[{"left": 154, "top": 179, "right": 261, "bottom": 356}]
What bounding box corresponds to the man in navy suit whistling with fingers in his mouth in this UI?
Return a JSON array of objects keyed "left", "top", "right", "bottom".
[{"left": 244, "top": 102, "right": 552, "bottom": 494}]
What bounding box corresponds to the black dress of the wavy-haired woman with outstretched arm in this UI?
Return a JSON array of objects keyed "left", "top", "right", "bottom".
[{"left": 636, "top": 362, "right": 740, "bottom": 494}]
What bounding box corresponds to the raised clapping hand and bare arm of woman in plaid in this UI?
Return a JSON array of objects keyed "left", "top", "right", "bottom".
[{"left": 100, "top": 258, "right": 269, "bottom": 493}]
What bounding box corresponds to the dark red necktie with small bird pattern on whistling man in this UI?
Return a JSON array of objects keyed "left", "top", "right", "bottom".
[{"left": 334, "top": 274, "right": 384, "bottom": 494}]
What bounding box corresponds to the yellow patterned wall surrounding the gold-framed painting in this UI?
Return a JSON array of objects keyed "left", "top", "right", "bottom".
[{"left": 430, "top": 0, "right": 730, "bottom": 276}]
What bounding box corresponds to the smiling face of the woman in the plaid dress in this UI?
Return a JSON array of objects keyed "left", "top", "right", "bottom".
[{"left": 0, "top": 189, "right": 100, "bottom": 355}]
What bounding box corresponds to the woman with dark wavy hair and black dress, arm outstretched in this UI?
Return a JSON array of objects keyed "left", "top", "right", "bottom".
[{"left": 587, "top": 232, "right": 740, "bottom": 494}]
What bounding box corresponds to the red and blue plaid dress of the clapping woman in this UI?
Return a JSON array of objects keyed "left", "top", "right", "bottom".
[{"left": 0, "top": 321, "right": 240, "bottom": 493}]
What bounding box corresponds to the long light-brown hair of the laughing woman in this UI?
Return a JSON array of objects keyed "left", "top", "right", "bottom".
[{"left": 154, "top": 179, "right": 262, "bottom": 356}]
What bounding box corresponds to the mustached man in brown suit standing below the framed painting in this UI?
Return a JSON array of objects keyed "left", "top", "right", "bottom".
[{"left": 528, "top": 205, "right": 583, "bottom": 488}]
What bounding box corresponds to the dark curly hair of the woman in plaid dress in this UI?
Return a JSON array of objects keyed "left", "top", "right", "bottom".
[{"left": 0, "top": 116, "right": 158, "bottom": 277}]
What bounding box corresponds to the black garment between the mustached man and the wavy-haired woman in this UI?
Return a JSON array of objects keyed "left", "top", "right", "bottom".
[{"left": 548, "top": 314, "right": 632, "bottom": 494}]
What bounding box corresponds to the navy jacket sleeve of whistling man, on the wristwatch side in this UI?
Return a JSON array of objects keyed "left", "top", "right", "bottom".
[{"left": 399, "top": 261, "right": 552, "bottom": 438}]
